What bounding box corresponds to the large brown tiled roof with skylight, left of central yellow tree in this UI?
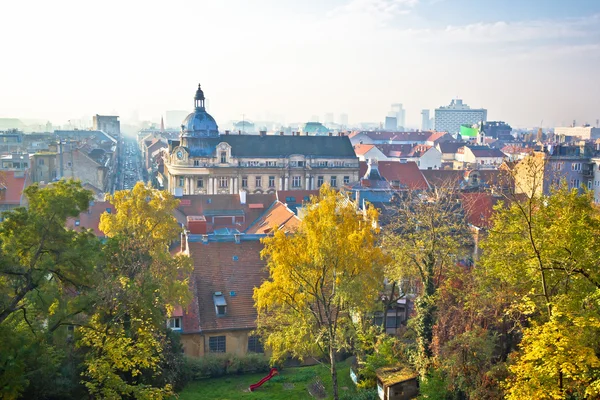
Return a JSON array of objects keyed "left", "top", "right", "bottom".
[{"left": 183, "top": 240, "right": 268, "bottom": 333}]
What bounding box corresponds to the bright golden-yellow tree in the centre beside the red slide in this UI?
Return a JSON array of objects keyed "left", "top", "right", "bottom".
[{"left": 254, "top": 187, "right": 387, "bottom": 399}]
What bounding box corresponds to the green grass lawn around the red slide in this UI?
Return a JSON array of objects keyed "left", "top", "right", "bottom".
[{"left": 179, "top": 360, "right": 355, "bottom": 400}]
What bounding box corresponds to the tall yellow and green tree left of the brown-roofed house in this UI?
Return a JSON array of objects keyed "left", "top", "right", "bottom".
[{"left": 78, "top": 182, "right": 191, "bottom": 399}]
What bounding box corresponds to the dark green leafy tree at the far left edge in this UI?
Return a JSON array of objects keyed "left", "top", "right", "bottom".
[{"left": 0, "top": 181, "right": 100, "bottom": 399}]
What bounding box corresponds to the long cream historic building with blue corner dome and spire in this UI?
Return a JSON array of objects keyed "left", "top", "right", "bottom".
[{"left": 161, "top": 87, "right": 358, "bottom": 196}]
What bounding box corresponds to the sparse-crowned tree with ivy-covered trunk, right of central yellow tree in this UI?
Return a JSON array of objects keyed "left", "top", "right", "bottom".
[{"left": 384, "top": 187, "right": 472, "bottom": 377}]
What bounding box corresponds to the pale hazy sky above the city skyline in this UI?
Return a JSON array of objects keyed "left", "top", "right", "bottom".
[{"left": 0, "top": 0, "right": 600, "bottom": 127}]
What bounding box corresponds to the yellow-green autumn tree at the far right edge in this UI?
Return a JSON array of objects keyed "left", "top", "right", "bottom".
[{"left": 482, "top": 184, "right": 600, "bottom": 399}]
